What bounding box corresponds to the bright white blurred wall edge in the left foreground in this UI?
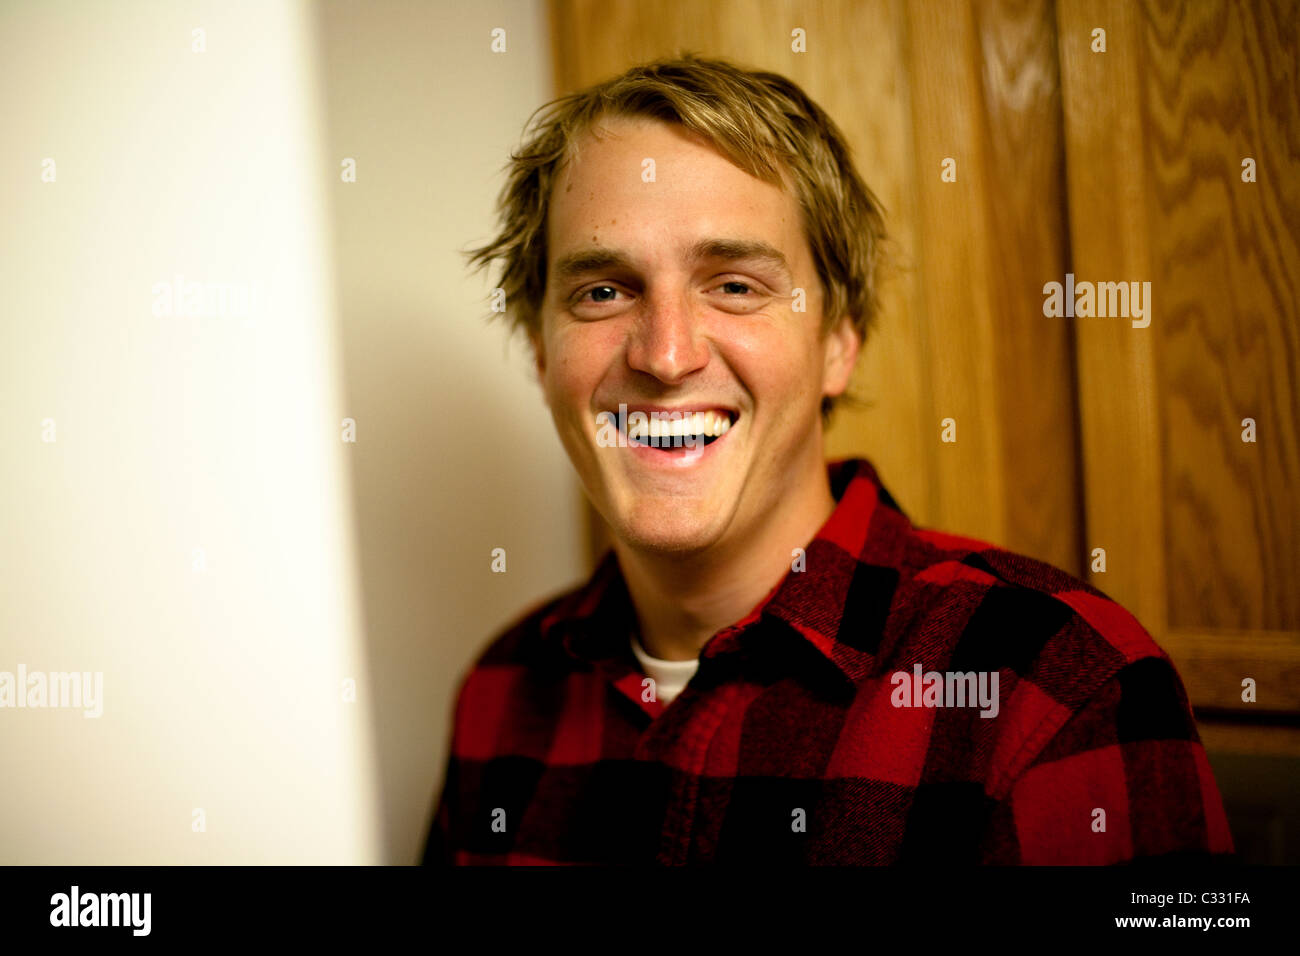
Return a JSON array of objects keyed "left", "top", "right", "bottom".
[{"left": 0, "top": 0, "right": 382, "bottom": 864}]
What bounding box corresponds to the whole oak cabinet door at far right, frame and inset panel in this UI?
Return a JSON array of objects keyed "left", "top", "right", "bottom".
[{"left": 1058, "top": 0, "right": 1300, "bottom": 711}]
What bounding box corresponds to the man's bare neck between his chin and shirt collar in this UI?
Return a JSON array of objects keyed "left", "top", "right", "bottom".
[{"left": 614, "top": 459, "right": 835, "bottom": 661}]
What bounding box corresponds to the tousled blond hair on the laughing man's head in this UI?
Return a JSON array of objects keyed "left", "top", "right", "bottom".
[{"left": 468, "top": 53, "right": 885, "bottom": 411}]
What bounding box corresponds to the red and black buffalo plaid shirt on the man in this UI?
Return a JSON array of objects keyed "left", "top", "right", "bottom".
[{"left": 425, "top": 460, "right": 1232, "bottom": 864}]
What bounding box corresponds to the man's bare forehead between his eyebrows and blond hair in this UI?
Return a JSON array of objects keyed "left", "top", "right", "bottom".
[{"left": 547, "top": 117, "right": 803, "bottom": 264}]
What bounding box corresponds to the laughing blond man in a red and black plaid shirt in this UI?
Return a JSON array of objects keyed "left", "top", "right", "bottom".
[{"left": 425, "top": 57, "right": 1231, "bottom": 864}]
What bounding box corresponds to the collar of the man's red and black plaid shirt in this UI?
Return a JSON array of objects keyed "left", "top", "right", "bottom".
[{"left": 541, "top": 458, "right": 911, "bottom": 682}]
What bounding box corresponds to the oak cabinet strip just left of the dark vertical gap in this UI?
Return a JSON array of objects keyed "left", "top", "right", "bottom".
[{"left": 907, "top": 0, "right": 1082, "bottom": 574}]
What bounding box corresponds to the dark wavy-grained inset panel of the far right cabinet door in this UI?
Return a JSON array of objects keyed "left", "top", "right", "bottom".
[{"left": 1138, "top": 3, "right": 1300, "bottom": 628}]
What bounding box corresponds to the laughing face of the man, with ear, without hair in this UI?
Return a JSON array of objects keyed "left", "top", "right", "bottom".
[{"left": 534, "top": 118, "right": 857, "bottom": 551}]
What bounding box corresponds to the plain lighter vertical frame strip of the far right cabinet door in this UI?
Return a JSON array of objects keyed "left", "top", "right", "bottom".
[{"left": 1045, "top": 0, "right": 1166, "bottom": 640}]
